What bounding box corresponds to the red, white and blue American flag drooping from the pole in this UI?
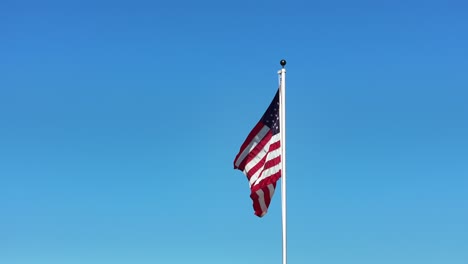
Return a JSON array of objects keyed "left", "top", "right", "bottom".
[{"left": 234, "top": 90, "right": 281, "bottom": 217}]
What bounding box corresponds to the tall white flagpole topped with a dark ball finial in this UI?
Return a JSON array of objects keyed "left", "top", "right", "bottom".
[{"left": 278, "top": 60, "right": 287, "bottom": 264}]
